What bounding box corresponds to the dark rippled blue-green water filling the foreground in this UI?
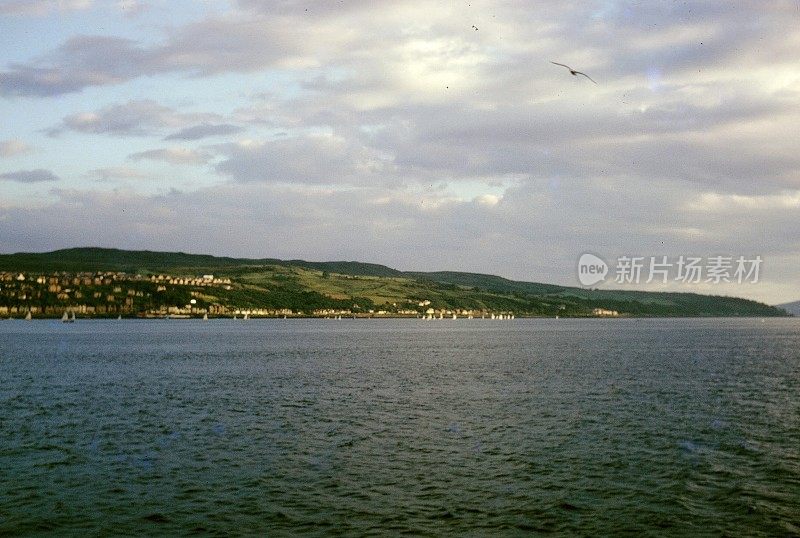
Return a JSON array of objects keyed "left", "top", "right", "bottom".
[{"left": 0, "top": 319, "right": 800, "bottom": 536}]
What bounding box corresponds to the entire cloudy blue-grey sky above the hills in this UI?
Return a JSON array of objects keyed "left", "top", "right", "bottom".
[{"left": 0, "top": 0, "right": 800, "bottom": 304}]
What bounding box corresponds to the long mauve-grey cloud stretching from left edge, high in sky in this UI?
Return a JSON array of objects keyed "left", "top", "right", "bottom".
[{"left": 0, "top": 14, "right": 318, "bottom": 97}]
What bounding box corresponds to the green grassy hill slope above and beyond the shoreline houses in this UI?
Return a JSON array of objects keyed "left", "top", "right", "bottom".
[{"left": 0, "top": 248, "right": 782, "bottom": 316}]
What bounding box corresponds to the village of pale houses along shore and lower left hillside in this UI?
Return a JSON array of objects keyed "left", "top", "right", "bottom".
[{"left": 0, "top": 271, "right": 515, "bottom": 320}]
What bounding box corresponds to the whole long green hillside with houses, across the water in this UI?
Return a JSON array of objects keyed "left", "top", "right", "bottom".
[{"left": 0, "top": 248, "right": 785, "bottom": 317}]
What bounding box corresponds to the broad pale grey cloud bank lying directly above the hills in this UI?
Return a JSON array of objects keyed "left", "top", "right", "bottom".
[{"left": 0, "top": 180, "right": 800, "bottom": 304}]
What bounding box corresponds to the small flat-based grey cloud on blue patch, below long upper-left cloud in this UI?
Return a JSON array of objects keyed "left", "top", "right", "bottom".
[{"left": 48, "top": 99, "right": 219, "bottom": 136}]
